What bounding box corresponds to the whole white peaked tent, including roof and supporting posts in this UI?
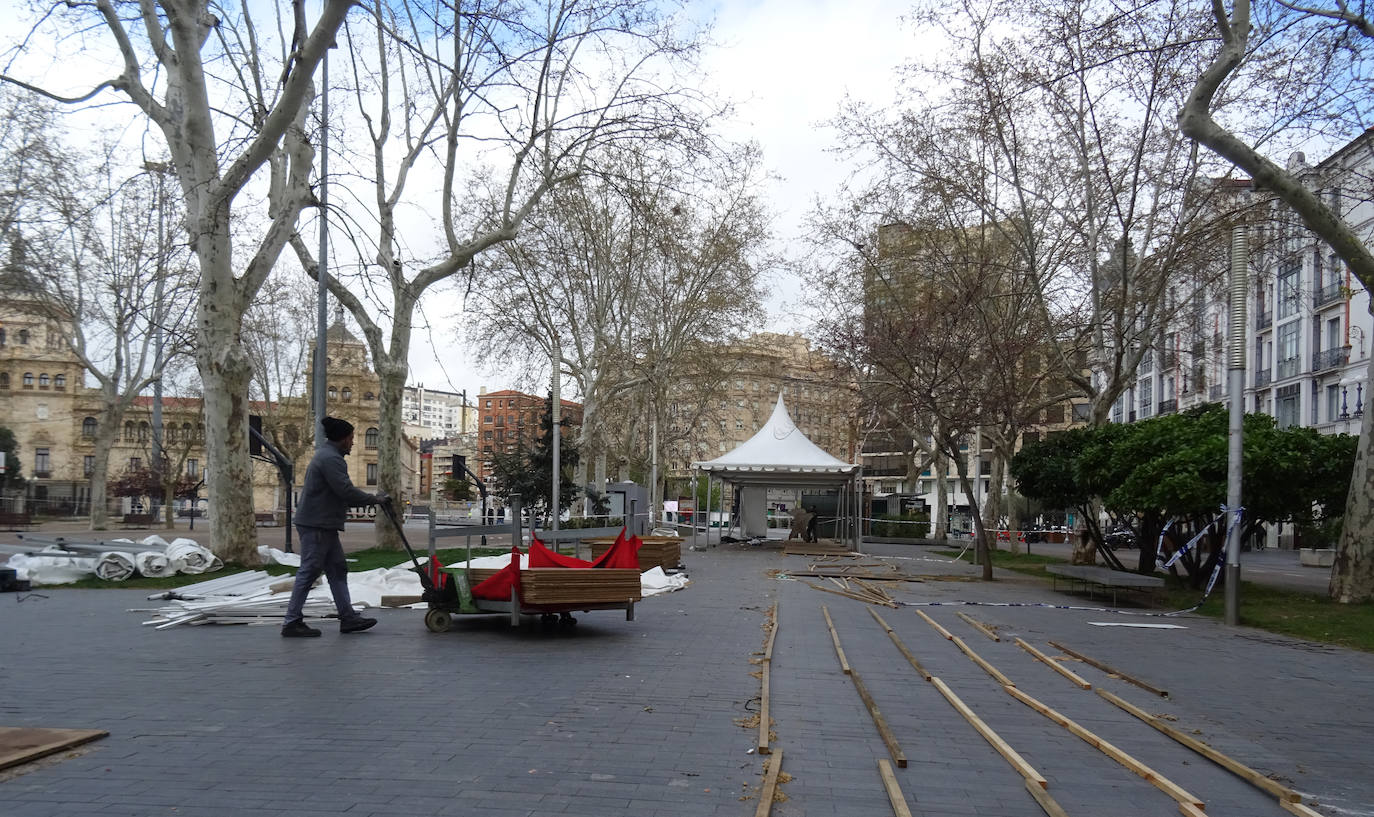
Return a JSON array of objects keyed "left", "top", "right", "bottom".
[{"left": 692, "top": 394, "right": 863, "bottom": 549}]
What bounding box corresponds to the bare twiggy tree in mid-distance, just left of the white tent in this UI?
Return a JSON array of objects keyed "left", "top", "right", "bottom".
[{"left": 469, "top": 150, "right": 767, "bottom": 510}]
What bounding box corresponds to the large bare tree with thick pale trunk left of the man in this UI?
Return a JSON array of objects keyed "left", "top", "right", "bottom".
[{"left": 0, "top": 0, "right": 352, "bottom": 563}]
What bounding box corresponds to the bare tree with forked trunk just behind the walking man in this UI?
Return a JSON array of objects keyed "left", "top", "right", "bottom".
[{"left": 293, "top": 0, "right": 719, "bottom": 546}]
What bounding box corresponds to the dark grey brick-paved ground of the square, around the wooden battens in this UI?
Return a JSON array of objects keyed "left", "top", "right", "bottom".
[{"left": 0, "top": 546, "right": 1374, "bottom": 817}]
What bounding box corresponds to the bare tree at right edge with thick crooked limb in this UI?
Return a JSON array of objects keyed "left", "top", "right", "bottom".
[{"left": 1178, "top": 0, "right": 1374, "bottom": 603}]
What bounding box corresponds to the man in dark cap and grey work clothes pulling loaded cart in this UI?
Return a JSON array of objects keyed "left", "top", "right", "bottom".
[{"left": 282, "top": 417, "right": 392, "bottom": 638}]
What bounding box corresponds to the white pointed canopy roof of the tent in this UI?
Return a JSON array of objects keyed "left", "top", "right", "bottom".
[{"left": 692, "top": 393, "right": 859, "bottom": 486}]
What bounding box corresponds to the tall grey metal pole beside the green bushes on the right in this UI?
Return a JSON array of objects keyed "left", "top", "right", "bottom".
[{"left": 1226, "top": 194, "right": 1250, "bottom": 626}]
